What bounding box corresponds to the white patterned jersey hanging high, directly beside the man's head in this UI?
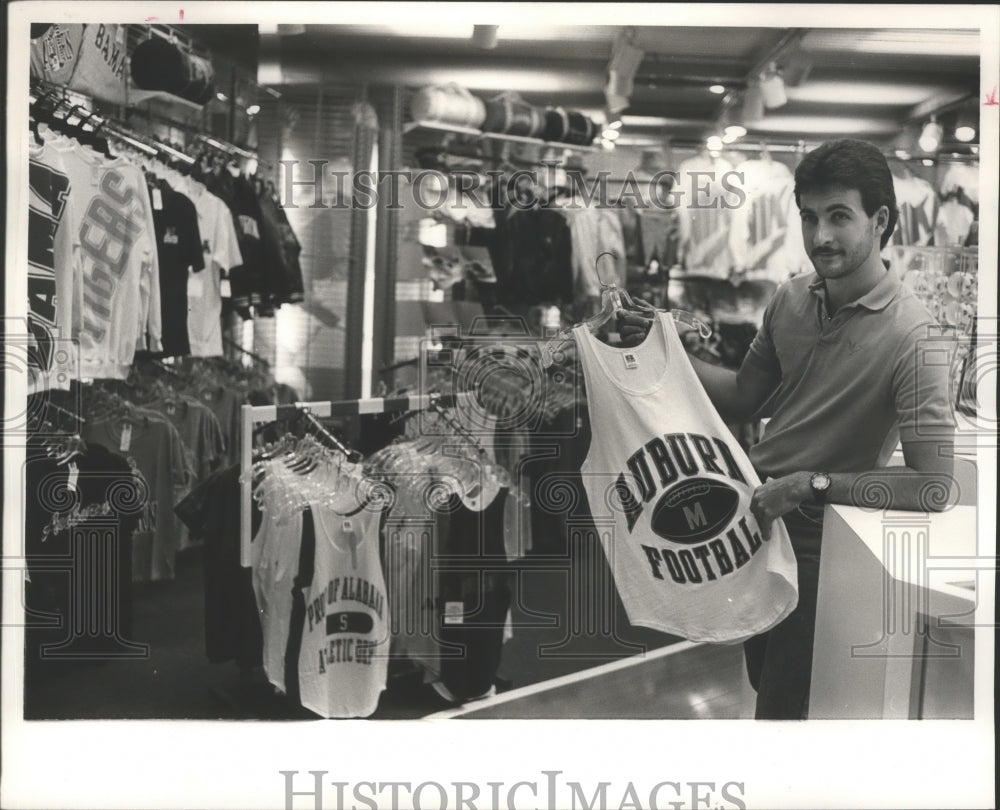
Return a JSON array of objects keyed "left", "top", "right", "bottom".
[{"left": 729, "top": 160, "right": 799, "bottom": 283}]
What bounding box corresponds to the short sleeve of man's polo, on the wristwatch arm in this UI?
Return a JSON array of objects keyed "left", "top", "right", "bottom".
[{"left": 892, "top": 324, "right": 957, "bottom": 442}]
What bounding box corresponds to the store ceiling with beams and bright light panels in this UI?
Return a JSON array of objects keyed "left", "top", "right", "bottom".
[{"left": 254, "top": 23, "right": 980, "bottom": 148}]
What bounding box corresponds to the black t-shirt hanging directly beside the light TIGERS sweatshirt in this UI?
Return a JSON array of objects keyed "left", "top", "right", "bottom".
[{"left": 150, "top": 182, "right": 205, "bottom": 357}]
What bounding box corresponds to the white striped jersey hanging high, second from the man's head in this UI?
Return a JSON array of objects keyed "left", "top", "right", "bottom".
[{"left": 677, "top": 156, "right": 735, "bottom": 278}]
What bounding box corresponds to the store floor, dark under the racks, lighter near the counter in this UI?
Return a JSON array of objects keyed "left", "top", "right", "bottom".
[{"left": 25, "top": 548, "right": 736, "bottom": 720}]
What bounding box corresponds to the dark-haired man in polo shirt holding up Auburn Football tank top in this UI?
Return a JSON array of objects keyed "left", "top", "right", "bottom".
[{"left": 619, "top": 140, "right": 954, "bottom": 719}]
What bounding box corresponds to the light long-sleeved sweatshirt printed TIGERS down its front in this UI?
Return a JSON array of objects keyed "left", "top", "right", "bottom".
[{"left": 60, "top": 148, "right": 161, "bottom": 379}]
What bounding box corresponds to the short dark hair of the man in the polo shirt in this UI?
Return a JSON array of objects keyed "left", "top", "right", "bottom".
[{"left": 795, "top": 138, "right": 899, "bottom": 247}]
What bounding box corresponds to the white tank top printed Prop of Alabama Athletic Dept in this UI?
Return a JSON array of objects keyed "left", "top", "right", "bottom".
[{"left": 285, "top": 504, "right": 390, "bottom": 717}]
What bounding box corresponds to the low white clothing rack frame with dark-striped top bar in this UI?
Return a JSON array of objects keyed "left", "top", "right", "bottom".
[{"left": 240, "top": 393, "right": 471, "bottom": 568}]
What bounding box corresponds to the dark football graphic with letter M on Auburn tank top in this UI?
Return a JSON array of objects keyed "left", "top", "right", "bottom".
[{"left": 650, "top": 478, "right": 740, "bottom": 543}]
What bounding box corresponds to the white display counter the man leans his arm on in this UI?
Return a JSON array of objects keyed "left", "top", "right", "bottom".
[{"left": 809, "top": 505, "right": 985, "bottom": 719}]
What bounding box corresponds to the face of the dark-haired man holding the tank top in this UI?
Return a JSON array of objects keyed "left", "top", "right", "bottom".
[{"left": 799, "top": 186, "right": 881, "bottom": 279}]
